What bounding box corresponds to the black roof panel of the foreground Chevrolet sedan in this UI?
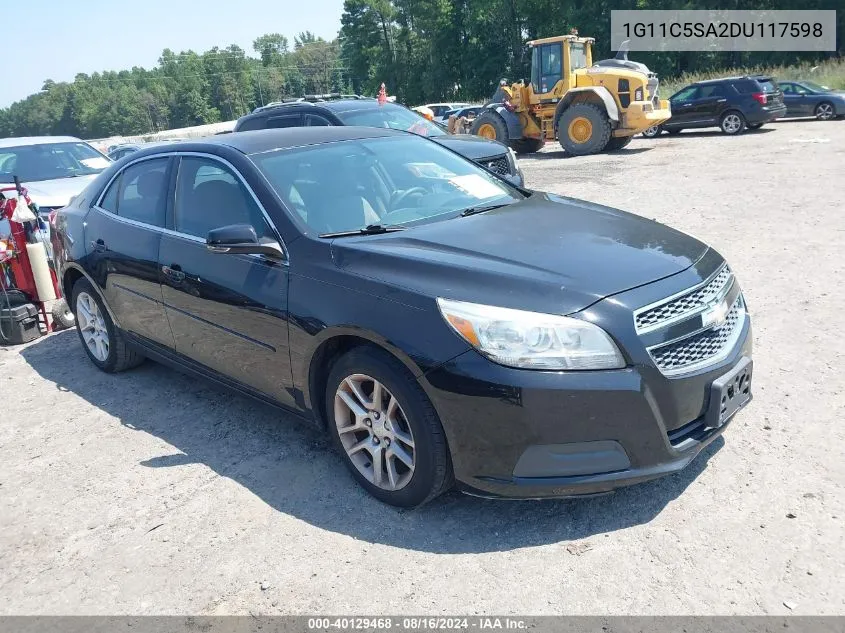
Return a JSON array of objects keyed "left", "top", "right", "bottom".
[{"left": 131, "top": 125, "right": 408, "bottom": 154}]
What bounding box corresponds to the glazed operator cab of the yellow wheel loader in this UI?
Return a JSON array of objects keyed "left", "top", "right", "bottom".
[{"left": 528, "top": 35, "right": 595, "bottom": 99}]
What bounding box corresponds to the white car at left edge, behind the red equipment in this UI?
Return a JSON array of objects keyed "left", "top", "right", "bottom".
[{"left": 0, "top": 136, "right": 112, "bottom": 241}]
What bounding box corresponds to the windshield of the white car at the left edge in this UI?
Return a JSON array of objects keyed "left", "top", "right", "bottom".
[{"left": 0, "top": 143, "right": 109, "bottom": 183}]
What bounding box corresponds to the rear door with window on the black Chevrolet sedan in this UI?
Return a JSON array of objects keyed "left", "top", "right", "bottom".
[{"left": 85, "top": 157, "right": 173, "bottom": 349}]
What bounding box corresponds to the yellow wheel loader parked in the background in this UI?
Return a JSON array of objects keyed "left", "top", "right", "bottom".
[{"left": 472, "top": 35, "right": 672, "bottom": 156}]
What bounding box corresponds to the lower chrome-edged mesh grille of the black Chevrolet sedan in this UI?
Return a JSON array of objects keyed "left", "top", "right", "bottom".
[{"left": 649, "top": 294, "right": 745, "bottom": 375}]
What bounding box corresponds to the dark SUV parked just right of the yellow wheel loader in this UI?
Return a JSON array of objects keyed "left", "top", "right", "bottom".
[{"left": 643, "top": 75, "right": 786, "bottom": 137}]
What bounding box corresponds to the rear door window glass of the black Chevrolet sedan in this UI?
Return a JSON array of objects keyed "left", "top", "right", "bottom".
[{"left": 113, "top": 158, "right": 170, "bottom": 227}]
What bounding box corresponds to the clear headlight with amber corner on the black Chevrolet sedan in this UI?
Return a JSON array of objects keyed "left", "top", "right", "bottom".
[{"left": 437, "top": 298, "right": 625, "bottom": 370}]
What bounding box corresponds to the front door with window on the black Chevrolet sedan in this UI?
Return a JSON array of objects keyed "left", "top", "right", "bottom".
[{"left": 159, "top": 155, "right": 294, "bottom": 405}]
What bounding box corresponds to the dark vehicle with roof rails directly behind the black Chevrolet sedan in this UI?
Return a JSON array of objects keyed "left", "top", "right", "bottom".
[{"left": 235, "top": 99, "right": 525, "bottom": 187}]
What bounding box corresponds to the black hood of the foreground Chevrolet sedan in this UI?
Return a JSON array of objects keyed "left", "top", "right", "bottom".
[{"left": 332, "top": 192, "right": 708, "bottom": 314}]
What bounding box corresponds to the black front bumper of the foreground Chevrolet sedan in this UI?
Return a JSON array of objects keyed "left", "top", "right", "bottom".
[{"left": 421, "top": 254, "right": 752, "bottom": 499}]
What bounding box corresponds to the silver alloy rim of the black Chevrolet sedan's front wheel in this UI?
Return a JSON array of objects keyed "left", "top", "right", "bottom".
[{"left": 334, "top": 374, "right": 416, "bottom": 491}]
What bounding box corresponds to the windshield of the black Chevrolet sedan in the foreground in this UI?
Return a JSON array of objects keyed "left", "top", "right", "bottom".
[{"left": 250, "top": 135, "right": 523, "bottom": 234}]
